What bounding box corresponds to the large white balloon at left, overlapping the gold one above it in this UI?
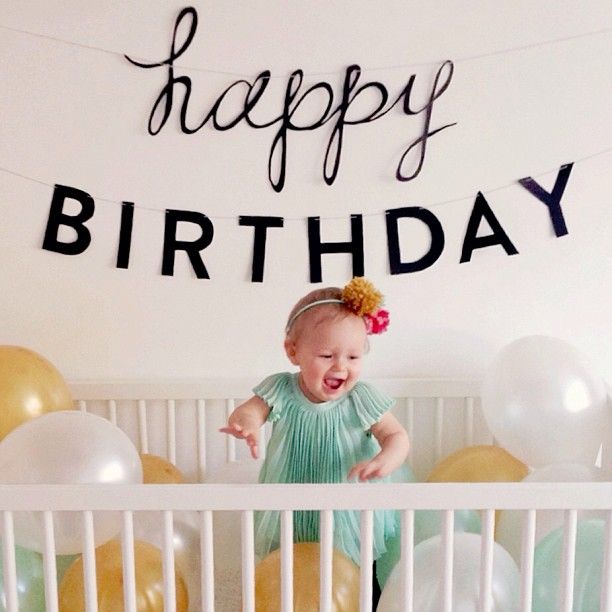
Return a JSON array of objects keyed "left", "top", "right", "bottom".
[{"left": 0, "top": 410, "right": 142, "bottom": 555}]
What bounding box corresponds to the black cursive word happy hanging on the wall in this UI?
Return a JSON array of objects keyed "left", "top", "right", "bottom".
[{"left": 124, "top": 7, "right": 456, "bottom": 192}]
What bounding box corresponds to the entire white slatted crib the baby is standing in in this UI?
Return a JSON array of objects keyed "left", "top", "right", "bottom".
[{"left": 0, "top": 379, "right": 612, "bottom": 612}]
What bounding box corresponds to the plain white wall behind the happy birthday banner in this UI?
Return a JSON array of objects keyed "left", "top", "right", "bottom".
[{"left": 0, "top": 0, "right": 612, "bottom": 380}]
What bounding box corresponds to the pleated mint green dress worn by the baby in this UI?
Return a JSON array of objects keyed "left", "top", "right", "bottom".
[{"left": 253, "top": 372, "right": 399, "bottom": 565}]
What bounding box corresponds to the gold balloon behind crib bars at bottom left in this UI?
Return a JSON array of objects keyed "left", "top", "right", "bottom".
[{"left": 59, "top": 540, "right": 188, "bottom": 612}]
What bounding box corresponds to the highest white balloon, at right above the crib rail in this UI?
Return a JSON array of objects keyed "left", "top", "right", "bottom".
[{"left": 481, "top": 336, "right": 611, "bottom": 467}]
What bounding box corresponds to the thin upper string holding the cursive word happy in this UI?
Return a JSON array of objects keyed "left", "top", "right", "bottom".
[{"left": 0, "top": 24, "right": 612, "bottom": 79}]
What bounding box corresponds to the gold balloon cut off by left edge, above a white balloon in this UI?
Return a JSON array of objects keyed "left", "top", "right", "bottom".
[{"left": 0, "top": 345, "right": 73, "bottom": 440}]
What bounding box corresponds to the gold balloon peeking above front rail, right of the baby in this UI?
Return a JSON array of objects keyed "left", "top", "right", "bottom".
[{"left": 427, "top": 445, "right": 529, "bottom": 482}]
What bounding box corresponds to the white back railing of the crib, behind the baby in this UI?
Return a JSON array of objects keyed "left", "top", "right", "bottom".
[{"left": 71, "top": 378, "right": 494, "bottom": 482}]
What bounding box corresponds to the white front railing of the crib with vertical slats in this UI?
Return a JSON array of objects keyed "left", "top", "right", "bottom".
[{"left": 0, "top": 483, "right": 612, "bottom": 612}]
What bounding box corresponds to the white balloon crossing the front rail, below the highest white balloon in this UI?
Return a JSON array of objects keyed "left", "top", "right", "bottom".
[{"left": 495, "top": 463, "right": 609, "bottom": 564}]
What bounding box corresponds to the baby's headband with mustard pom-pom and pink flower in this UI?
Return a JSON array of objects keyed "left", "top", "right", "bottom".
[{"left": 285, "top": 276, "right": 389, "bottom": 335}]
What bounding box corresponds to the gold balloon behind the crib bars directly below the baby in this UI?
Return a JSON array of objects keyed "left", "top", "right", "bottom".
[{"left": 255, "top": 542, "right": 359, "bottom": 612}]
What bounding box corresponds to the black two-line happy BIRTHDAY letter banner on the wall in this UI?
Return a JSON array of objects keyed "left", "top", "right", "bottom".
[{"left": 0, "top": 7, "right": 607, "bottom": 283}]
